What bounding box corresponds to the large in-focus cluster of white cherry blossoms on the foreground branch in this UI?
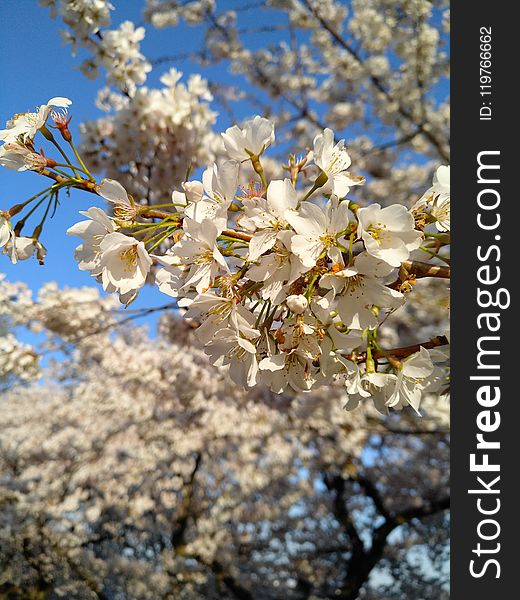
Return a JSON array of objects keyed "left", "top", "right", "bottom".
[{"left": 69, "top": 116, "right": 446, "bottom": 411}]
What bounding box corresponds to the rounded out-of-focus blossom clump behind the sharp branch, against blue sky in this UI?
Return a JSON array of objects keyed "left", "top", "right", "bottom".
[{"left": 80, "top": 69, "right": 216, "bottom": 204}]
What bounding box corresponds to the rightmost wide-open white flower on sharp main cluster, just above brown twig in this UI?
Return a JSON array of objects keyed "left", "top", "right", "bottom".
[{"left": 357, "top": 204, "right": 422, "bottom": 267}]
